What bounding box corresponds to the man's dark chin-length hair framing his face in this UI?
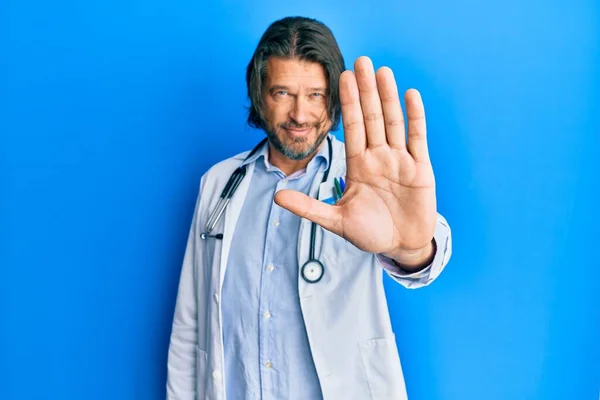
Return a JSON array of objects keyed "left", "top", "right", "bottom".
[{"left": 246, "top": 17, "right": 345, "bottom": 131}]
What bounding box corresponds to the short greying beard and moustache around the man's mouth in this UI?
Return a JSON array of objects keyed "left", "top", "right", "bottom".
[{"left": 265, "top": 121, "right": 327, "bottom": 161}]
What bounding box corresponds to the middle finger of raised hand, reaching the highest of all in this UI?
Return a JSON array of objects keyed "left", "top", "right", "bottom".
[{"left": 354, "top": 57, "right": 387, "bottom": 147}]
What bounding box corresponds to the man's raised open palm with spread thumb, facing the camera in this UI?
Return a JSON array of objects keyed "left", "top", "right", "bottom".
[{"left": 275, "top": 57, "right": 437, "bottom": 265}]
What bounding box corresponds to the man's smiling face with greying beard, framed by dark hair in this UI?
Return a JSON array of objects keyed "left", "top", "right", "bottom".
[{"left": 263, "top": 57, "right": 331, "bottom": 160}]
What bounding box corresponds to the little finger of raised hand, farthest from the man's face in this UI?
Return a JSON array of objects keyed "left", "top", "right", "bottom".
[{"left": 404, "top": 89, "right": 429, "bottom": 162}]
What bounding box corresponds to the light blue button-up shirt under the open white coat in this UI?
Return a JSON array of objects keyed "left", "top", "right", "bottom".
[{"left": 221, "top": 142, "right": 330, "bottom": 400}]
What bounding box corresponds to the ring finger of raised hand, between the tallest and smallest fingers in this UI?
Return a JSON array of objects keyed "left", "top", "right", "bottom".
[{"left": 376, "top": 67, "right": 406, "bottom": 150}]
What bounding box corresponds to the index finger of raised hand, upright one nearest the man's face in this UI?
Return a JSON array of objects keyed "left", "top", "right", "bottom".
[{"left": 340, "top": 71, "right": 367, "bottom": 158}]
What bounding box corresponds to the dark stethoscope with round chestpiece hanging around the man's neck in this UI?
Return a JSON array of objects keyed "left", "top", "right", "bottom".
[{"left": 200, "top": 136, "right": 333, "bottom": 283}]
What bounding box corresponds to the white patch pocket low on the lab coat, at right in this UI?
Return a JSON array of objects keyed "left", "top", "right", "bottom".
[{"left": 359, "top": 338, "right": 407, "bottom": 400}]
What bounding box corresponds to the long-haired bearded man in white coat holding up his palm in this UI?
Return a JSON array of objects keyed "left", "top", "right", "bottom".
[{"left": 167, "top": 18, "right": 451, "bottom": 400}]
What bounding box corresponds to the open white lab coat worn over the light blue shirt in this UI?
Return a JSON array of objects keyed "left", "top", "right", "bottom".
[{"left": 167, "top": 136, "right": 452, "bottom": 400}]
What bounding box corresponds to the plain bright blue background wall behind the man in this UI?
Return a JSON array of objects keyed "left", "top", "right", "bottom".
[{"left": 0, "top": 0, "right": 600, "bottom": 400}]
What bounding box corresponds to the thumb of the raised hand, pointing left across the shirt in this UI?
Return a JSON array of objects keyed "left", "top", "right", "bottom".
[{"left": 275, "top": 189, "right": 342, "bottom": 235}]
